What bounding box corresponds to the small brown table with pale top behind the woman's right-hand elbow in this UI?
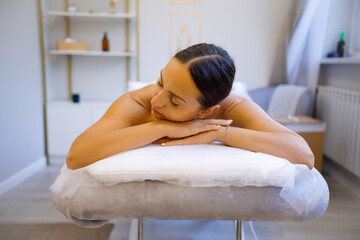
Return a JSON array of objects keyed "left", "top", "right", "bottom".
[{"left": 272, "top": 115, "right": 326, "bottom": 173}]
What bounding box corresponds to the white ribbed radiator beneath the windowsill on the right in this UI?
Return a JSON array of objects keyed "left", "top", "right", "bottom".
[{"left": 316, "top": 86, "right": 360, "bottom": 177}]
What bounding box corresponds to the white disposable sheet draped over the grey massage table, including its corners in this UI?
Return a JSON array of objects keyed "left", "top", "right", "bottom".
[{"left": 50, "top": 144, "right": 322, "bottom": 214}]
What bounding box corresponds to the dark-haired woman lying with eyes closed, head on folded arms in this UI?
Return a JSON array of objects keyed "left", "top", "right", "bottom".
[{"left": 66, "top": 43, "right": 314, "bottom": 169}]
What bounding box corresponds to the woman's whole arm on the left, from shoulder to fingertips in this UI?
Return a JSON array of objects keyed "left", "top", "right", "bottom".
[{"left": 66, "top": 95, "right": 229, "bottom": 170}]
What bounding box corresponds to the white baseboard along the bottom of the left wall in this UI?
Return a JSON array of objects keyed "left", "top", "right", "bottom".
[{"left": 0, "top": 156, "right": 46, "bottom": 196}]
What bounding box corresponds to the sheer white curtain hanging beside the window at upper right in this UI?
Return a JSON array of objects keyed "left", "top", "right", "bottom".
[{"left": 286, "top": 0, "right": 330, "bottom": 112}]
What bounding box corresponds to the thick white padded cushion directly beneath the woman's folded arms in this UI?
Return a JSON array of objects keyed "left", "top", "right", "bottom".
[{"left": 86, "top": 144, "right": 294, "bottom": 188}]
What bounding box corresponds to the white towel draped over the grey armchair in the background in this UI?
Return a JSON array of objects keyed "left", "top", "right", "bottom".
[{"left": 267, "top": 84, "right": 308, "bottom": 116}]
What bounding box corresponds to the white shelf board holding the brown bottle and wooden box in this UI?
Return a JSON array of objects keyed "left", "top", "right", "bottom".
[{"left": 49, "top": 49, "right": 136, "bottom": 57}]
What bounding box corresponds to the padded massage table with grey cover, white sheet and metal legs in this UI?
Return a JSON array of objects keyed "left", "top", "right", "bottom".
[{"left": 50, "top": 142, "right": 329, "bottom": 239}]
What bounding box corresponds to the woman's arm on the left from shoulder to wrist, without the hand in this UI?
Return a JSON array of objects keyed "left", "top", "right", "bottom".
[{"left": 66, "top": 94, "right": 162, "bottom": 170}]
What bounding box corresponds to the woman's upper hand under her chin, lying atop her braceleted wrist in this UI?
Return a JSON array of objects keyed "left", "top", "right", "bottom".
[{"left": 159, "top": 119, "right": 232, "bottom": 138}]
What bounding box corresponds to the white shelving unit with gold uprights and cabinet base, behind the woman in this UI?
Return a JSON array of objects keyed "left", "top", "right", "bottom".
[{"left": 39, "top": 0, "right": 139, "bottom": 159}]
